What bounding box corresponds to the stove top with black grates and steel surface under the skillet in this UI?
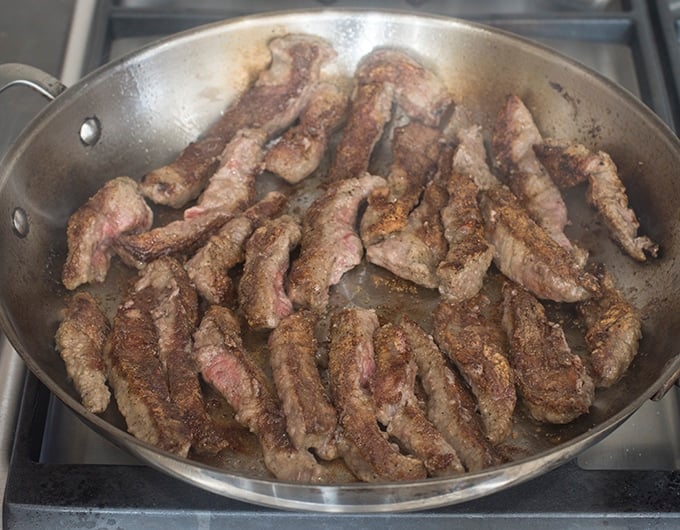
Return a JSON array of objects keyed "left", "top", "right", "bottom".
[{"left": 0, "top": 0, "right": 680, "bottom": 529}]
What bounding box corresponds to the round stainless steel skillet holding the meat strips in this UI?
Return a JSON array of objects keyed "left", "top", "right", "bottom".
[{"left": 0, "top": 10, "right": 680, "bottom": 512}]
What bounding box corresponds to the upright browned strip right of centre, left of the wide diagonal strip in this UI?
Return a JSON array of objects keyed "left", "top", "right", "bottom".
[{"left": 436, "top": 165, "right": 494, "bottom": 302}]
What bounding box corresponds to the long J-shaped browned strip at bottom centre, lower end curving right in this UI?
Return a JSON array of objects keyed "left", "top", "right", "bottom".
[{"left": 328, "top": 307, "right": 426, "bottom": 482}]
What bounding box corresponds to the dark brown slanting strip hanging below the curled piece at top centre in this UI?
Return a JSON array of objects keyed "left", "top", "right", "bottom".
[{"left": 328, "top": 83, "right": 394, "bottom": 182}]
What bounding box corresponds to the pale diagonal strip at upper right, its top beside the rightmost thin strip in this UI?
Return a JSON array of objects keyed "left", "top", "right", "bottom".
[{"left": 492, "top": 95, "right": 587, "bottom": 266}]
